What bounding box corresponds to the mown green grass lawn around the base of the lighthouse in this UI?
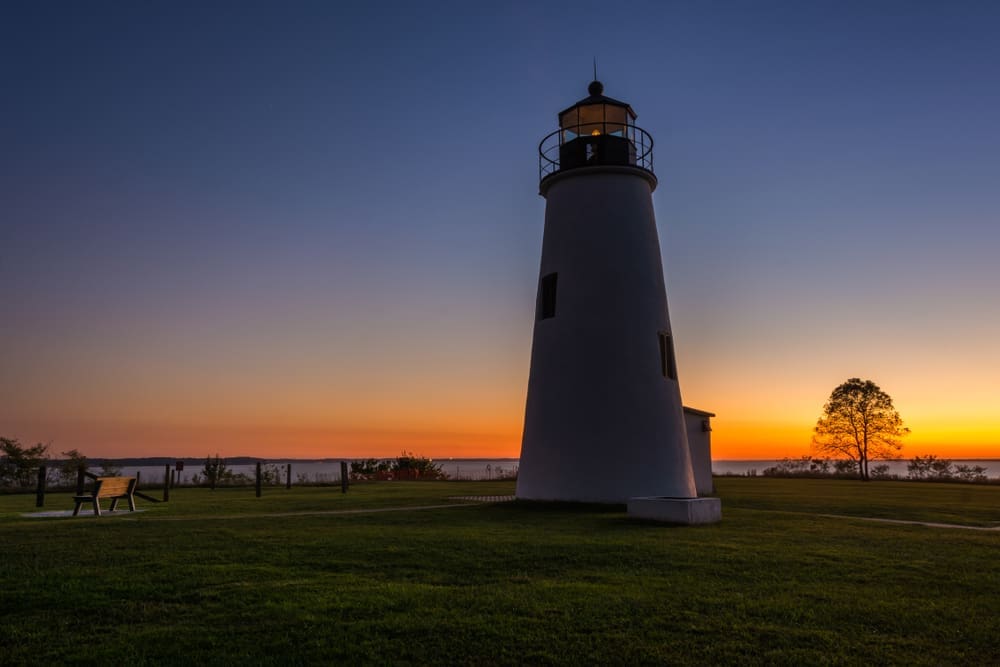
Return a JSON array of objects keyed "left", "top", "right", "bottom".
[{"left": 0, "top": 478, "right": 1000, "bottom": 665}]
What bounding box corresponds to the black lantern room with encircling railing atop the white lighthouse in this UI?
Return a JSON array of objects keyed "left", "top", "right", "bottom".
[{"left": 539, "top": 81, "right": 653, "bottom": 180}]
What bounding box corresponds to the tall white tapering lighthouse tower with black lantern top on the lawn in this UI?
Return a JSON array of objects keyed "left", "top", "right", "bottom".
[{"left": 517, "top": 81, "right": 720, "bottom": 523}]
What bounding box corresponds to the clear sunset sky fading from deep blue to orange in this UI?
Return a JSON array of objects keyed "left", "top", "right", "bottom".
[{"left": 0, "top": 0, "right": 1000, "bottom": 459}]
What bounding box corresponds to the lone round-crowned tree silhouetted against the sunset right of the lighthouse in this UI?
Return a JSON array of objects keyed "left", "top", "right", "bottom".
[{"left": 813, "top": 378, "right": 910, "bottom": 480}]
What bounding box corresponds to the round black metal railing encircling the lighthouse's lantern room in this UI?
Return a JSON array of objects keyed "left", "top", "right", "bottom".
[{"left": 538, "top": 122, "right": 653, "bottom": 181}]
